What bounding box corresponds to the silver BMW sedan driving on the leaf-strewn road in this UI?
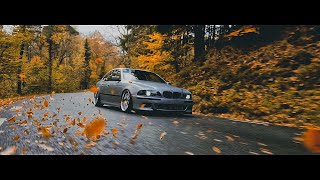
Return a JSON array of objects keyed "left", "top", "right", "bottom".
[{"left": 94, "top": 68, "right": 193, "bottom": 114}]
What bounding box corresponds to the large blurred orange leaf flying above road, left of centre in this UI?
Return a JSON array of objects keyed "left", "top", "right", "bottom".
[{"left": 83, "top": 118, "right": 106, "bottom": 139}]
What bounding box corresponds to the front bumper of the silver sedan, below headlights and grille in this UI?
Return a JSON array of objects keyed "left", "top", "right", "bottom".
[{"left": 132, "top": 95, "right": 194, "bottom": 114}]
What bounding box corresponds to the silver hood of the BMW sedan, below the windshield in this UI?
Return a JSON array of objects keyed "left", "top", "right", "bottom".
[{"left": 134, "top": 80, "right": 190, "bottom": 93}]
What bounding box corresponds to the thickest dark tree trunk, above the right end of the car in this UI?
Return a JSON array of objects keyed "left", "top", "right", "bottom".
[{"left": 194, "top": 25, "right": 205, "bottom": 63}]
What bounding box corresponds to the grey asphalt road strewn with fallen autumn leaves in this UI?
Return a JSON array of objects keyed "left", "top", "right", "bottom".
[{"left": 0, "top": 92, "right": 312, "bottom": 155}]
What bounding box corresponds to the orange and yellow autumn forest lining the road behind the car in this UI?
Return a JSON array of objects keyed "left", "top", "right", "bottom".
[{"left": 0, "top": 25, "right": 320, "bottom": 125}]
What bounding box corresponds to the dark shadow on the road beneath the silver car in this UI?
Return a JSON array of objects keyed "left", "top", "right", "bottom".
[{"left": 103, "top": 106, "right": 193, "bottom": 118}]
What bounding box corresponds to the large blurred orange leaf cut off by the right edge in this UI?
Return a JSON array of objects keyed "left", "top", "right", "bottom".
[{"left": 302, "top": 128, "right": 320, "bottom": 153}]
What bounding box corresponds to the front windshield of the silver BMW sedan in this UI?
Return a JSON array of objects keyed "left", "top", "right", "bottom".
[{"left": 123, "top": 69, "right": 165, "bottom": 83}]
